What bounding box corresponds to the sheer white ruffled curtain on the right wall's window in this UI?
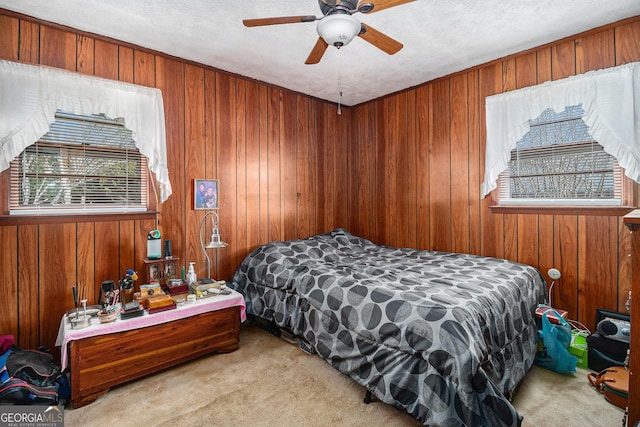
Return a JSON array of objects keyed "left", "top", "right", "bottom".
[{"left": 481, "top": 62, "right": 640, "bottom": 198}]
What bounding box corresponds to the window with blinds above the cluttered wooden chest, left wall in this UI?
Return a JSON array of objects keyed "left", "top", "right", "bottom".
[{"left": 9, "top": 110, "right": 148, "bottom": 215}]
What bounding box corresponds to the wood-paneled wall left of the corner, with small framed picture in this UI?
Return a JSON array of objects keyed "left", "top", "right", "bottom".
[{"left": 0, "top": 11, "right": 350, "bottom": 348}]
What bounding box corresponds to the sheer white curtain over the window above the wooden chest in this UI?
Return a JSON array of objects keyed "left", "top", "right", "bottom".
[{"left": 0, "top": 61, "right": 172, "bottom": 202}]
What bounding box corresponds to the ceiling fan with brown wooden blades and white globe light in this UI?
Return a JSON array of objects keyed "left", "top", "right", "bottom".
[{"left": 242, "top": 0, "right": 416, "bottom": 64}]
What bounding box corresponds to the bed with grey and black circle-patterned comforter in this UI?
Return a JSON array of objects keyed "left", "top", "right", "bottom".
[{"left": 230, "top": 229, "right": 546, "bottom": 426}]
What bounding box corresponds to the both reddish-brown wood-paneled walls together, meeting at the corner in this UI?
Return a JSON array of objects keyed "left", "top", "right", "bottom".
[{"left": 0, "top": 10, "right": 640, "bottom": 347}]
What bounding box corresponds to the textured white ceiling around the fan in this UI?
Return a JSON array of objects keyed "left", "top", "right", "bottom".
[{"left": 0, "top": 0, "right": 640, "bottom": 105}]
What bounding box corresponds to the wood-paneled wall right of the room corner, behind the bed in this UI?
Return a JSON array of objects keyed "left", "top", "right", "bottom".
[{"left": 347, "top": 17, "right": 640, "bottom": 331}]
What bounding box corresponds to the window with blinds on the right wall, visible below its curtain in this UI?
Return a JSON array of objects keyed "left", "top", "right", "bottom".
[{"left": 499, "top": 105, "right": 623, "bottom": 206}]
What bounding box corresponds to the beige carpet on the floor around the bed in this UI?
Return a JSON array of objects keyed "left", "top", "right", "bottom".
[{"left": 65, "top": 327, "right": 623, "bottom": 427}]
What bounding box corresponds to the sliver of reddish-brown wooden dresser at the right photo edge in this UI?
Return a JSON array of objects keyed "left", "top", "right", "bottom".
[{"left": 624, "top": 209, "right": 640, "bottom": 426}]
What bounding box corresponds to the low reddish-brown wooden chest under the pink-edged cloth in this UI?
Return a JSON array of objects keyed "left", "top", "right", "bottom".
[{"left": 69, "top": 306, "right": 240, "bottom": 408}]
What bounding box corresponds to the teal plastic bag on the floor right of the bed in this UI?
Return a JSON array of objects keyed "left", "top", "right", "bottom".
[{"left": 534, "top": 309, "right": 578, "bottom": 374}]
